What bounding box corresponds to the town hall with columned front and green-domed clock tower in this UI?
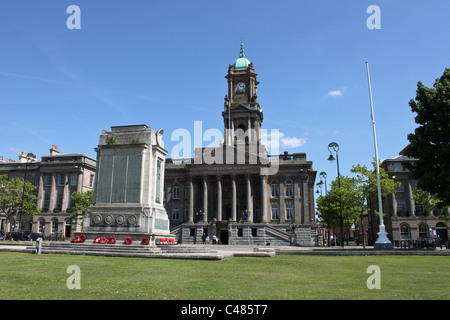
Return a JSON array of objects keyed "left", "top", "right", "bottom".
[{"left": 164, "top": 45, "right": 320, "bottom": 246}]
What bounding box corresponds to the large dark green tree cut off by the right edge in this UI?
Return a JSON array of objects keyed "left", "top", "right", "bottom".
[{"left": 403, "top": 68, "right": 450, "bottom": 208}]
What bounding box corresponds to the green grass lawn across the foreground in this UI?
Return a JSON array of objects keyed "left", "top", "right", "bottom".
[{"left": 0, "top": 252, "right": 450, "bottom": 300}]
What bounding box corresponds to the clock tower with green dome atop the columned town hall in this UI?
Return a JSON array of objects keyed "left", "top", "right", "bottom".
[{"left": 222, "top": 42, "right": 263, "bottom": 145}]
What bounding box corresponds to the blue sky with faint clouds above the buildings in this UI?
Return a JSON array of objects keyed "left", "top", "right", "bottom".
[{"left": 0, "top": 0, "right": 450, "bottom": 188}]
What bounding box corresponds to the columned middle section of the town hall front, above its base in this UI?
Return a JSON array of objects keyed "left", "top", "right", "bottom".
[{"left": 166, "top": 167, "right": 314, "bottom": 225}]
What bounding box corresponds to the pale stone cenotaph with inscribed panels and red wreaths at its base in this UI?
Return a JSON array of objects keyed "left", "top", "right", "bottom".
[{"left": 81, "top": 125, "right": 171, "bottom": 245}]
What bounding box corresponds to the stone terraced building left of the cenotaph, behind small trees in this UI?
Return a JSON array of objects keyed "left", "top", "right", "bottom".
[{"left": 0, "top": 145, "right": 96, "bottom": 239}]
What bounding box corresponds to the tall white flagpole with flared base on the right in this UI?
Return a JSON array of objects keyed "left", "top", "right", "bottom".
[{"left": 366, "top": 61, "right": 392, "bottom": 250}]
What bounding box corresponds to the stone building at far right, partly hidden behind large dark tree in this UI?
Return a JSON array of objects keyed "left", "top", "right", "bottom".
[{"left": 366, "top": 152, "right": 450, "bottom": 246}]
